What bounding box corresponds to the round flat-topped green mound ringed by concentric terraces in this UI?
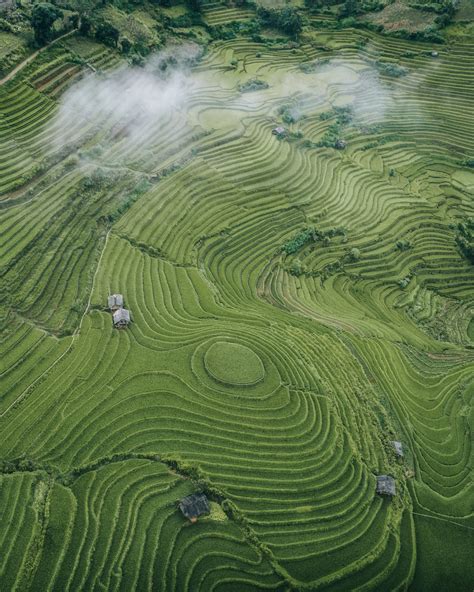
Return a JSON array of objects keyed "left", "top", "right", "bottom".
[{"left": 204, "top": 341, "right": 265, "bottom": 386}]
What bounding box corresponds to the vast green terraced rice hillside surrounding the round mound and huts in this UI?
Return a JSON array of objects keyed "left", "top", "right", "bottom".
[{"left": 0, "top": 5, "right": 474, "bottom": 592}]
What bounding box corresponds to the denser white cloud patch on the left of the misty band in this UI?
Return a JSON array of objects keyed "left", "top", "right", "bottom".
[{"left": 52, "top": 44, "right": 200, "bottom": 153}]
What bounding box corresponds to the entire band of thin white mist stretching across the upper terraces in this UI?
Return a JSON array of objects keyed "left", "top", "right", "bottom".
[{"left": 49, "top": 44, "right": 436, "bottom": 163}]
